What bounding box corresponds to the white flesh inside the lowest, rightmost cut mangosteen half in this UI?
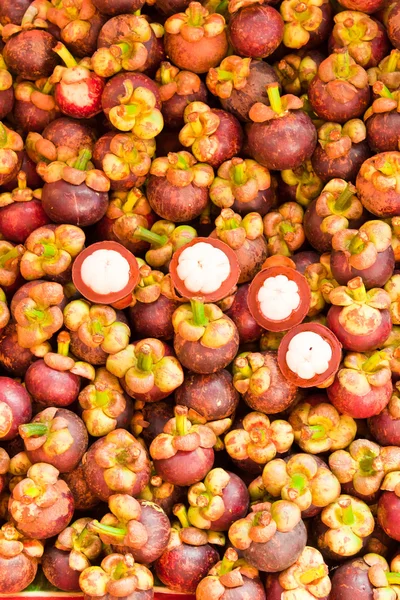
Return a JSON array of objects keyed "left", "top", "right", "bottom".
[{"left": 286, "top": 331, "right": 332, "bottom": 379}]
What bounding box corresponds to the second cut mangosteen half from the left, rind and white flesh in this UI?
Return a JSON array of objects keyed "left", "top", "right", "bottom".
[{"left": 169, "top": 237, "right": 240, "bottom": 302}]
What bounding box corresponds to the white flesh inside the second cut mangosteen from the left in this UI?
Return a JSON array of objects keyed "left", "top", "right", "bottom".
[{"left": 176, "top": 242, "right": 231, "bottom": 294}]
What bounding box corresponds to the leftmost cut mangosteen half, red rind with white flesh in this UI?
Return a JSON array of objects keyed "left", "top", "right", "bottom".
[{"left": 72, "top": 242, "right": 140, "bottom": 308}]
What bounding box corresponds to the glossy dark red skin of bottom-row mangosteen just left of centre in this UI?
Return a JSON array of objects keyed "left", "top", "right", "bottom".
[{"left": 154, "top": 544, "right": 220, "bottom": 594}]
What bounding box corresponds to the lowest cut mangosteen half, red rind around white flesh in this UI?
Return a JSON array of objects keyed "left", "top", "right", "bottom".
[{"left": 278, "top": 323, "right": 342, "bottom": 388}]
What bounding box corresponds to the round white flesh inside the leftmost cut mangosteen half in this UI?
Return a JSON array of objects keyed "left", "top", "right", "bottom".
[{"left": 81, "top": 249, "right": 130, "bottom": 295}]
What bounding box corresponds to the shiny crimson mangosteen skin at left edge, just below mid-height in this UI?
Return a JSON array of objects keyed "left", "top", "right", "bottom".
[{"left": 0, "top": 377, "right": 32, "bottom": 441}]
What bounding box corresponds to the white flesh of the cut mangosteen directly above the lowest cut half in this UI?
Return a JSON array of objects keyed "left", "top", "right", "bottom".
[{"left": 257, "top": 275, "right": 300, "bottom": 321}]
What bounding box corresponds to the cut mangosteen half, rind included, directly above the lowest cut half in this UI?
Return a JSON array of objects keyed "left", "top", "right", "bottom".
[{"left": 247, "top": 265, "right": 311, "bottom": 331}]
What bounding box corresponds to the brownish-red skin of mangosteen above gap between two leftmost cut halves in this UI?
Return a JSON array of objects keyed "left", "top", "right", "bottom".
[{"left": 147, "top": 175, "right": 208, "bottom": 223}]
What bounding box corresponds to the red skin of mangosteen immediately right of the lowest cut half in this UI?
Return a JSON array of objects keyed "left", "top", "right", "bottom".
[{"left": 326, "top": 375, "right": 393, "bottom": 419}]
